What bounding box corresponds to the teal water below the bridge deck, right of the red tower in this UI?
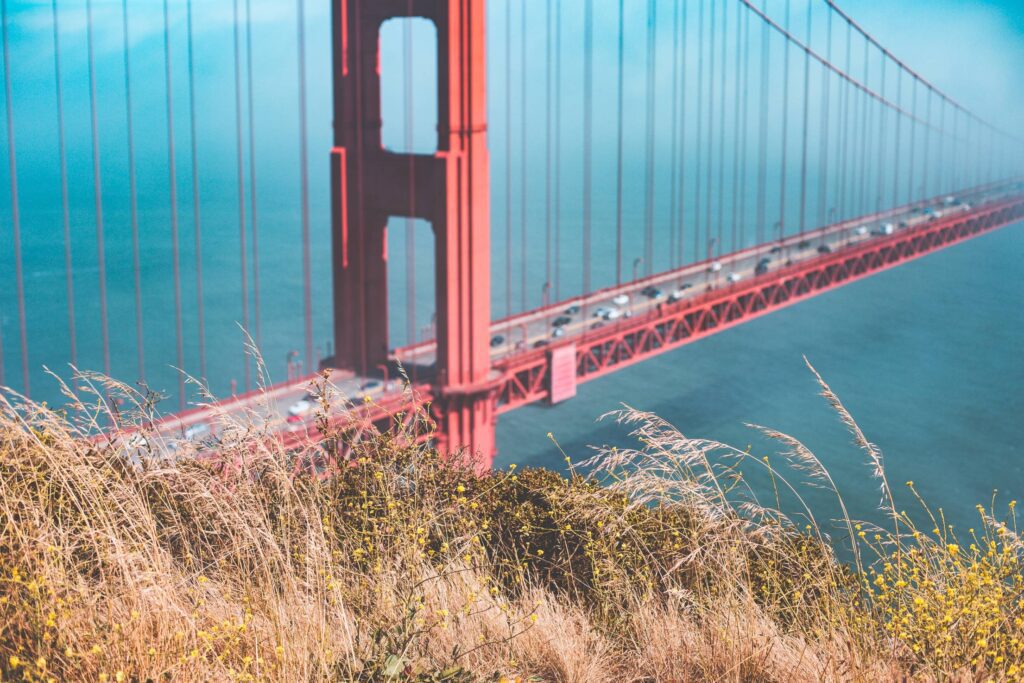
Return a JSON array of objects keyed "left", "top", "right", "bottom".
[{"left": 496, "top": 224, "right": 1024, "bottom": 526}]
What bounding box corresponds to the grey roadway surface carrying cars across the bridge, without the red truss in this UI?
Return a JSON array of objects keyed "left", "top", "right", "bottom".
[{"left": 138, "top": 180, "right": 1024, "bottom": 454}]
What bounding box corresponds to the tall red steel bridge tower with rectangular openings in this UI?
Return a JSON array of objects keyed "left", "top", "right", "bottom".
[{"left": 331, "top": 0, "right": 497, "bottom": 464}]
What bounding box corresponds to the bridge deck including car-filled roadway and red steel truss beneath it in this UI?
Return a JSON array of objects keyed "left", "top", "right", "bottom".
[{"left": 138, "top": 182, "right": 1024, "bottom": 458}]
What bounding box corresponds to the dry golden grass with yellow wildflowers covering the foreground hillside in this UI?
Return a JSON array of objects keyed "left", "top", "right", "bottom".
[{"left": 0, "top": 368, "right": 1024, "bottom": 681}]
